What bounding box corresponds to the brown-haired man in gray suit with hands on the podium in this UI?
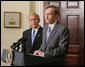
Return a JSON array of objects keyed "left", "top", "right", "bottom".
[{"left": 34, "top": 5, "right": 69, "bottom": 66}]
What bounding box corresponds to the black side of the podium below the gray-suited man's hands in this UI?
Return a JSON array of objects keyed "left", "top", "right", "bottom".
[{"left": 24, "top": 54, "right": 61, "bottom": 66}]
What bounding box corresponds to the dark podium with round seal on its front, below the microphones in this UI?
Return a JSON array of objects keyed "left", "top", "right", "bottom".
[{"left": 2, "top": 49, "right": 64, "bottom": 66}]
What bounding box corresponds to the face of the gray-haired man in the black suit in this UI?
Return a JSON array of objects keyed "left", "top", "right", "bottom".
[{"left": 29, "top": 15, "right": 40, "bottom": 29}]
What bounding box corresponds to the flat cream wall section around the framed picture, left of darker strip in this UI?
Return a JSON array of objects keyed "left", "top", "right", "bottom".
[{"left": 1, "top": 1, "right": 30, "bottom": 66}]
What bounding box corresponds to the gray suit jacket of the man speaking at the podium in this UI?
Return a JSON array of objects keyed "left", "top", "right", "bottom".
[{"left": 39, "top": 22, "right": 69, "bottom": 65}]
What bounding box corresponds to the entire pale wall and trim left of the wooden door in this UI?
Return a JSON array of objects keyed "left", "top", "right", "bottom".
[{"left": 1, "top": 1, "right": 43, "bottom": 66}]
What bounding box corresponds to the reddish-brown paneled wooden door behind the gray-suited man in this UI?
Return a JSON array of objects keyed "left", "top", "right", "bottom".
[{"left": 44, "top": 1, "right": 84, "bottom": 66}]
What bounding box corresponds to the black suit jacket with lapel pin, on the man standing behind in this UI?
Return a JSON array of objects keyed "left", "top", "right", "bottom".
[{"left": 22, "top": 26, "right": 42, "bottom": 54}]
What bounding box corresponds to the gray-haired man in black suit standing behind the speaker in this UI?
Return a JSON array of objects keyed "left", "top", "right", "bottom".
[{"left": 22, "top": 13, "right": 42, "bottom": 54}]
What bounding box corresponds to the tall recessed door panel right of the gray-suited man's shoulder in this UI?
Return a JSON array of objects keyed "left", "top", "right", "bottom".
[{"left": 67, "top": 15, "right": 79, "bottom": 45}]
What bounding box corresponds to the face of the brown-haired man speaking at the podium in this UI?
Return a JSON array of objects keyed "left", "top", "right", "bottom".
[{"left": 45, "top": 8, "right": 57, "bottom": 24}]
